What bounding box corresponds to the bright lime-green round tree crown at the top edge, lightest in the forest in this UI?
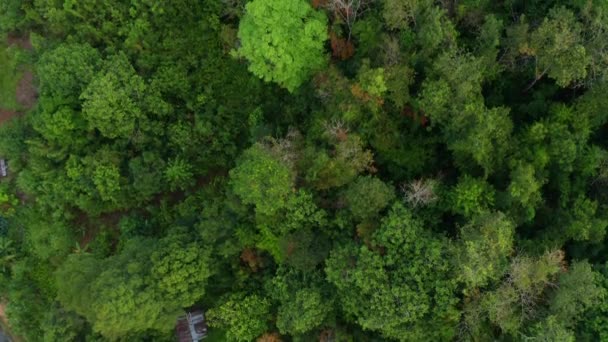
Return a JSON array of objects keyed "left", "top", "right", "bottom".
[{"left": 237, "top": 0, "right": 327, "bottom": 92}]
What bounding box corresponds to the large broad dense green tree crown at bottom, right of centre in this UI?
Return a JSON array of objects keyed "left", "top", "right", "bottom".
[{"left": 326, "top": 204, "right": 459, "bottom": 340}]
